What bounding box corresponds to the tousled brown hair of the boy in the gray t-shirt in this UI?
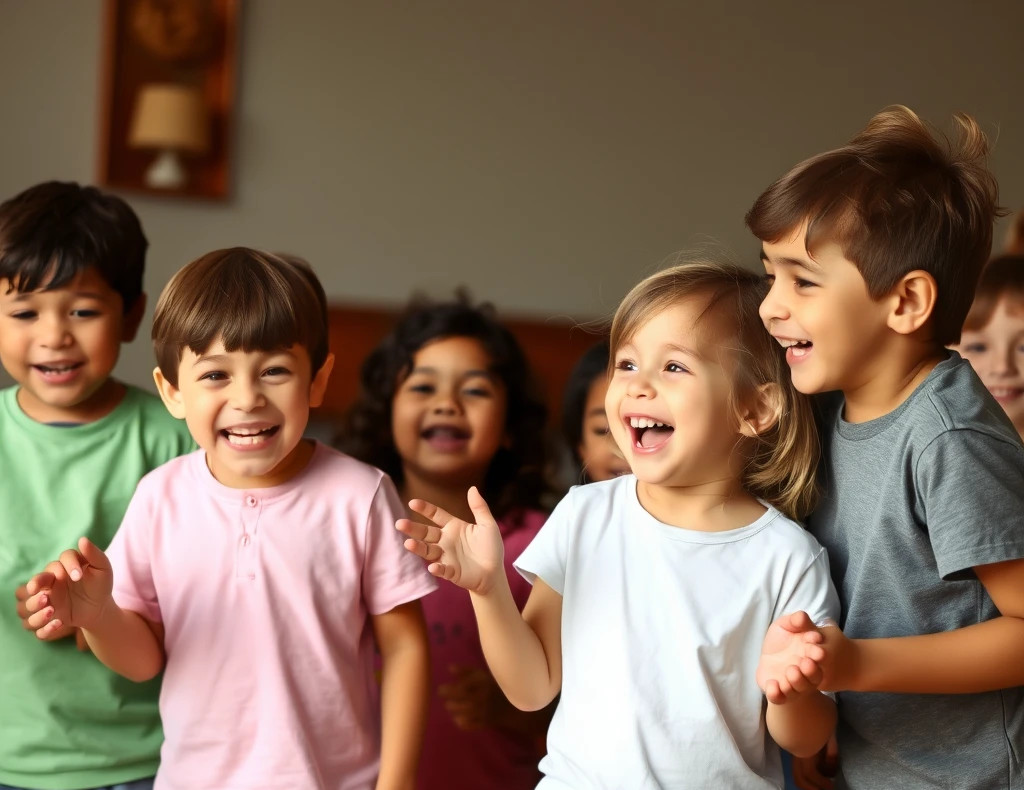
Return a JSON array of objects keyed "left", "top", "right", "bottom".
[{"left": 746, "top": 106, "right": 1002, "bottom": 345}]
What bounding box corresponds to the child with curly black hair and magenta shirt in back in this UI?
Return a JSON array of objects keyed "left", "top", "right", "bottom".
[{"left": 341, "top": 295, "right": 549, "bottom": 790}]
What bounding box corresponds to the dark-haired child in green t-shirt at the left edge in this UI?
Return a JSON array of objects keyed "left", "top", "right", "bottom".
[{"left": 0, "top": 181, "right": 194, "bottom": 790}]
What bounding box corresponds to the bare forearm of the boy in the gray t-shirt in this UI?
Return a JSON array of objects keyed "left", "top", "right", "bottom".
[{"left": 821, "top": 617, "right": 1024, "bottom": 694}]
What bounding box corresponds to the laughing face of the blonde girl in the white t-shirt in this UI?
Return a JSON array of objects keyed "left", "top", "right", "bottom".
[{"left": 605, "top": 297, "right": 740, "bottom": 489}]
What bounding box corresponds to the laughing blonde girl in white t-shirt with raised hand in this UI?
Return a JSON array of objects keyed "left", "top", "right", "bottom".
[{"left": 397, "top": 262, "right": 839, "bottom": 788}]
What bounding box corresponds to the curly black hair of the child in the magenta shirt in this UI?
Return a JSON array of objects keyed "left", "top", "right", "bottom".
[{"left": 335, "top": 291, "right": 547, "bottom": 517}]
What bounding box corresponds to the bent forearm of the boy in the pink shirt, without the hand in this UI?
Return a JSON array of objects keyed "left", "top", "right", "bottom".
[{"left": 82, "top": 600, "right": 164, "bottom": 682}]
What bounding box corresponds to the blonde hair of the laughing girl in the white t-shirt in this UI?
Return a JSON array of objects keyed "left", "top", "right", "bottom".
[{"left": 609, "top": 261, "right": 819, "bottom": 518}]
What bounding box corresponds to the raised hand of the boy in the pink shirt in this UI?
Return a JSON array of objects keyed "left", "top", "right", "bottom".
[{"left": 25, "top": 538, "right": 114, "bottom": 639}]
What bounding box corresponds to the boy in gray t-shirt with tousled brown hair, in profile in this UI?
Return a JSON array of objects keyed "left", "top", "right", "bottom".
[{"left": 746, "top": 108, "right": 1024, "bottom": 790}]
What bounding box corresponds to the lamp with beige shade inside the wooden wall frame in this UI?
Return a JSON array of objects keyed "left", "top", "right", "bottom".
[{"left": 128, "top": 83, "right": 210, "bottom": 190}]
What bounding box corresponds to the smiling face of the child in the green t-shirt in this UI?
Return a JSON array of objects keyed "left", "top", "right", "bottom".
[{"left": 0, "top": 267, "right": 145, "bottom": 422}]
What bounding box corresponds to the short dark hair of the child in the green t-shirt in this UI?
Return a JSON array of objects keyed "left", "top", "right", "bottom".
[{"left": 0, "top": 181, "right": 148, "bottom": 314}]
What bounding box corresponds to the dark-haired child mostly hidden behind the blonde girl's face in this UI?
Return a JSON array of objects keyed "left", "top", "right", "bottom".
[{"left": 562, "top": 340, "right": 630, "bottom": 483}]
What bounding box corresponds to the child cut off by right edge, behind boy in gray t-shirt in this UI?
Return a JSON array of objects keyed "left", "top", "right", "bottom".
[{"left": 953, "top": 255, "right": 1024, "bottom": 438}]
